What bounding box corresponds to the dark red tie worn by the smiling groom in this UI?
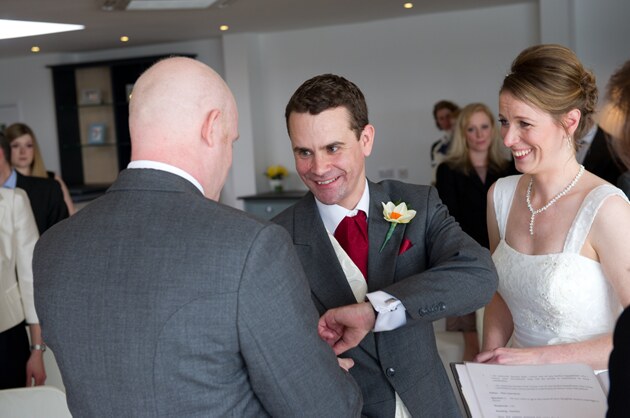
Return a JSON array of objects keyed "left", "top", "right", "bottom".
[{"left": 335, "top": 210, "right": 369, "bottom": 280}]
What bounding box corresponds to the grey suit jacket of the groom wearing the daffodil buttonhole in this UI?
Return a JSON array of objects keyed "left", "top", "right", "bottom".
[{"left": 273, "top": 181, "right": 498, "bottom": 418}]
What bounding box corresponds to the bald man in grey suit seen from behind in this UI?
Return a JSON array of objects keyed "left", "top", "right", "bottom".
[{"left": 33, "top": 57, "right": 362, "bottom": 417}]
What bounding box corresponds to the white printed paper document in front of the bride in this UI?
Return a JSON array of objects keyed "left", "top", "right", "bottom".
[{"left": 453, "top": 363, "right": 607, "bottom": 418}]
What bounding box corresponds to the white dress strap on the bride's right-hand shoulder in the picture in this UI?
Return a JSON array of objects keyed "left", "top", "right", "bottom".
[{"left": 564, "top": 184, "right": 630, "bottom": 254}]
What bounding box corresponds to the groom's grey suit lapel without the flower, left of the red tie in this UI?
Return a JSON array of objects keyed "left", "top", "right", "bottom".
[{"left": 293, "top": 193, "right": 356, "bottom": 309}]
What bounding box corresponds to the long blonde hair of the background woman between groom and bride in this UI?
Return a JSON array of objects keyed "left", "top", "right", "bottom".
[{"left": 444, "top": 103, "right": 508, "bottom": 174}]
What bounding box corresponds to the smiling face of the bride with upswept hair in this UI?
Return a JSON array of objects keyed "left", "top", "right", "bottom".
[{"left": 499, "top": 92, "right": 571, "bottom": 174}]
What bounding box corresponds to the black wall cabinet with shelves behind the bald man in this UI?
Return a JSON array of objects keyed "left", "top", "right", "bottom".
[{"left": 50, "top": 54, "right": 194, "bottom": 197}]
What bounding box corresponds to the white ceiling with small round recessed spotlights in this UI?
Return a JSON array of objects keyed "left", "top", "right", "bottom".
[{"left": 0, "top": 0, "right": 535, "bottom": 58}]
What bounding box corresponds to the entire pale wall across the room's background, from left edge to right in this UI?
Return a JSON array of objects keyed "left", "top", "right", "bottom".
[{"left": 0, "top": 0, "right": 630, "bottom": 207}]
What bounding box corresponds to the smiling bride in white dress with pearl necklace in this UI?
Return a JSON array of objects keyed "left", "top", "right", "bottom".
[{"left": 475, "top": 45, "right": 630, "bottom": 369}]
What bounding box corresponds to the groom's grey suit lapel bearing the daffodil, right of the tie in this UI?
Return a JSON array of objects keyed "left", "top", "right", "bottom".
[{"left": 368, "top": 182, "right": 406, "bottom": 292}]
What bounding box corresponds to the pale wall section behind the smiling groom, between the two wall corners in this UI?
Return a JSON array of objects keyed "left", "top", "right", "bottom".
[{"left": 257, "top": 4, "right": 538, "bottom": 189}]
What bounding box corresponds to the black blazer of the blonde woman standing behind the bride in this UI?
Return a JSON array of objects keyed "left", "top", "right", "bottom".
[{"left": 435, "top": 163, "right": 516, "bottom": 248}]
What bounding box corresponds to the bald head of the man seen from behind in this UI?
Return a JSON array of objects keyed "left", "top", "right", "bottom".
[{"left": 129, "top": 57, "right": 238, "bottom": 199}]
